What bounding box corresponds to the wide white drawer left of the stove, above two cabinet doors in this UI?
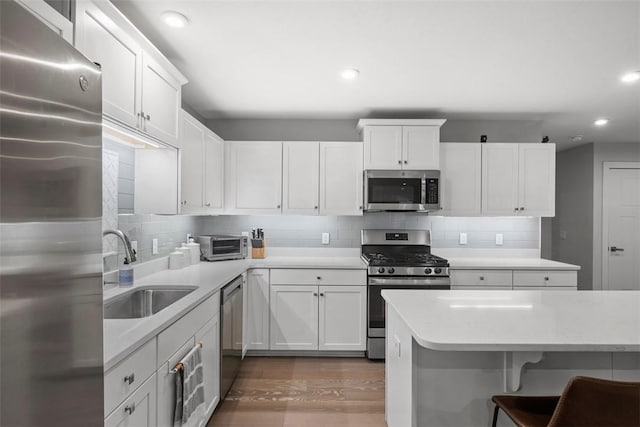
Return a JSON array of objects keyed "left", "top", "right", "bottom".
[{"left": 271, "top": 268, "right": 367, "bottom": 286}]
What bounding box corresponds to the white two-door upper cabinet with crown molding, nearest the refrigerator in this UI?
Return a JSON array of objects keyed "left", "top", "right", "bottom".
[{"left": 75, "top": 0, "right": 187, "bottom": 145}]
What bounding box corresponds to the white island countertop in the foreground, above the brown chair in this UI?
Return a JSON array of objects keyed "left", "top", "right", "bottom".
[{"left": 382, "top": 290, "right": 640, "bottom": 352}]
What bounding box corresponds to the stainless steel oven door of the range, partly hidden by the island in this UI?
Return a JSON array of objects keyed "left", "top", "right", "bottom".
[{"left": 367, "top": 277, "right": 451, "bottom": 338}]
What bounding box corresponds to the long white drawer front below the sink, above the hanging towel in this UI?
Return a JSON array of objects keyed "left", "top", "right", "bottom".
[{"left": 157, "top": 292, "right": 220, "bottom": 368}]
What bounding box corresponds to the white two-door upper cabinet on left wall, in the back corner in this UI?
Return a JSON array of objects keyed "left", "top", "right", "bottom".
[{"left": 180, "top": 111, "right": 224, "bottom": 214}]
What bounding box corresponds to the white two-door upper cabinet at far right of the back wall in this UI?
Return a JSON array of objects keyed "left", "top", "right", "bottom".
[{"left": 482, "top": 143, "right": 555, "bottom": 216}]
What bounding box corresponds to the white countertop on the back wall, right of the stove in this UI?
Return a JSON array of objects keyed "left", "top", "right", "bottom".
[{"left": 444, "top": 258, "right": 580, "bottom": 270}]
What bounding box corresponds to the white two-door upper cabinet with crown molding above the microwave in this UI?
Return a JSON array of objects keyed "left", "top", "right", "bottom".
[{"left": 358, "top": 119, "right": 445, "bottom": 170}]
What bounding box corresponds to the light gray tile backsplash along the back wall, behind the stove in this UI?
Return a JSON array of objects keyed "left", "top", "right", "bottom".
[{"left": 197, "top": 212, "right": 540, "bottom": 249}]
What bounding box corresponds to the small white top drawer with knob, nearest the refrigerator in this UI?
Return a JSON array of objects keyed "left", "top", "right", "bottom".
[{"left": 104, "top": 338, "right": 156, "bottom": 416}]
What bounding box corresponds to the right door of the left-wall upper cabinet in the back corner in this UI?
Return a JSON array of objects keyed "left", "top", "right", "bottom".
[{"left": 204, "top": 132, "right": 224, "bottom": 213}]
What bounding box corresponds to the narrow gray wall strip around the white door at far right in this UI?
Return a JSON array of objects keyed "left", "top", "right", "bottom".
[{"left": 593, "top": 141, "right": 640, "bottom": 289}]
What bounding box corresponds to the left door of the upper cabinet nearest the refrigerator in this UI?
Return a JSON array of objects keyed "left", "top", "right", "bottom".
[{"left": 76, "top": 1, "right": 142, "bottom": 127}]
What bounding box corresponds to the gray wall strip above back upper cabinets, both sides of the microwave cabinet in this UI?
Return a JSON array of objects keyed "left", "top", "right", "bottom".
[{"left": 204, "top": 119, "right": 542, "bottom": 142}]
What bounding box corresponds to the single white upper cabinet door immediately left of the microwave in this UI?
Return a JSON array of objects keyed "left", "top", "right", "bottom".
[{"left": 320, "top": 142, "right": 363, "bottom": 215}]
